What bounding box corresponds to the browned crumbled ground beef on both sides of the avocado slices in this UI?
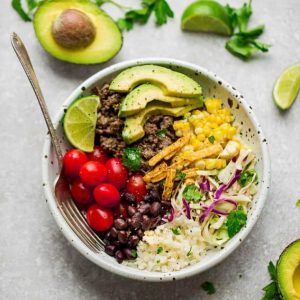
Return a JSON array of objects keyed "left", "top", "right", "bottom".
[{"left": 93, "top": 84, "right": 176, "bottom": 172}]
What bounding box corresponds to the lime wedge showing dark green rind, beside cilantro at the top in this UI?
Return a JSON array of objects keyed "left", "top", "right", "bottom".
[{"left": 181, "top": 1, "right": 232, "bottom": 35}]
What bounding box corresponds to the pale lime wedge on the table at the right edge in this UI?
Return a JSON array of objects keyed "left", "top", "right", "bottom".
[{"left": 273, "top": 62, "right": 300, "bottom": 110}]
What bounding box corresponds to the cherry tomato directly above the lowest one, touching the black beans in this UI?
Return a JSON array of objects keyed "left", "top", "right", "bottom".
[{"left": 93, "top": 183, "right": 120, "bottom": 207}]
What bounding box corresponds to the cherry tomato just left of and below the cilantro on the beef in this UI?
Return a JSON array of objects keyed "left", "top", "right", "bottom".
[{"left": 106, "top": 158, "right": 128, "bottom": 189}]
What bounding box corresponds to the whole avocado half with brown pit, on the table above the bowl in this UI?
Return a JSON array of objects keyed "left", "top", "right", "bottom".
[{"left": 34, "top": 0, "right": 122, "bottom": 64}]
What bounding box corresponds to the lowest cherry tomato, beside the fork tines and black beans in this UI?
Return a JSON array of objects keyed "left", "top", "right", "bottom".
[{"left": 86, "top": 204, "right": 114, "bottom": 231}]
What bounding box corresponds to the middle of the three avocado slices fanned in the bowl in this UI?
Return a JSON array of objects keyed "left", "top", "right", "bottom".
[{"left": 119, "top": 83, "right": 202, "bottom": 117}]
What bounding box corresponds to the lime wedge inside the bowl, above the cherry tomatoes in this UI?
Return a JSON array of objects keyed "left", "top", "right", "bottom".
[{"left": 64, "top": 96, "right": 100, "bottom": 152}]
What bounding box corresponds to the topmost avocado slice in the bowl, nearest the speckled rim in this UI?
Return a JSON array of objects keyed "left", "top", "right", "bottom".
[{"left": 109, "top": 65, "right": 202, "bottom": 97}]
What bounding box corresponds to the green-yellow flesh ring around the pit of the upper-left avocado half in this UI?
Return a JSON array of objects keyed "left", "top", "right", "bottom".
[{"left": 34, "top": 0, "right": 122, "bottom": 64}]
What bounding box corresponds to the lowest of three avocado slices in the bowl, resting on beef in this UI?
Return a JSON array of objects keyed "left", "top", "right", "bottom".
[{"left": 122, "top": 101, "right": 201, "bottom": 144}]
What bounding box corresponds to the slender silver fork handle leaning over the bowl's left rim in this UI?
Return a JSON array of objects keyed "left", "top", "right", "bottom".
[{"left": 10, "top": 32, "right": 63, "bottom": 170}]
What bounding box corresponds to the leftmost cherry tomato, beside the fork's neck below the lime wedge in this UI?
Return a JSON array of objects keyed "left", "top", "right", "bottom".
[{"left": 63, "top": 149, "right": 88, "bottom": 177}]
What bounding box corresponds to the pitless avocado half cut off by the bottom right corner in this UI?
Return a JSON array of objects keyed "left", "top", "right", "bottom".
[{"left": 277, "top": 240, "right": 300, "bottom": 300}]
